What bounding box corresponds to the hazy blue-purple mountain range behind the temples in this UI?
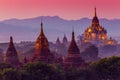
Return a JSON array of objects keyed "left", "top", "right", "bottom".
[{"left": 0, "top": 16, "right": 120, "bottom": 42}]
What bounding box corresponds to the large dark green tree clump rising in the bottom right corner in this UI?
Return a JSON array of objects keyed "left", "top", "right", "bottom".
[{"left": 91, "top": 57, "right": 120, "bottom": 80}]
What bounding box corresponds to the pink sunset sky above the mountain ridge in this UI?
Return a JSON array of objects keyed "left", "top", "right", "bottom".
[{"left": 0, "top": 0, "right": 120, "bottom": 20}]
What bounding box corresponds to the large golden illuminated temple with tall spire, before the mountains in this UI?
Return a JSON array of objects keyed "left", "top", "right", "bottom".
[{"left": 84, "top": 8, "right": 107, "bottom": 44}]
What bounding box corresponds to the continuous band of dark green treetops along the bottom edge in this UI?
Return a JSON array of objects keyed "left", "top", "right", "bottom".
[{"left": 0, "top": 57, "right": 120, "bottom": 80}]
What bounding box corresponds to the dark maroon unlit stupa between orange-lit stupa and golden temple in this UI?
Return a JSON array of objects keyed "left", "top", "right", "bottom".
[{"left": 63, "top": 32, "right": 84, "bottom": 67}]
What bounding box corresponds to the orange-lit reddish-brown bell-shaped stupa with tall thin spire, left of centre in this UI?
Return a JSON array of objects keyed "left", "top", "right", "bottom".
[{"left": 31, "top": 22, "right": 53, "bottom": 63}]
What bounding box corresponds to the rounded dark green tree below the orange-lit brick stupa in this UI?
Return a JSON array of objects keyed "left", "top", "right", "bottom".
[{"left": 24, "top": 62, "right": 64, "bottom": 80}]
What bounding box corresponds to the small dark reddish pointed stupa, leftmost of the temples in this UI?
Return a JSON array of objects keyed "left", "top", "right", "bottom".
[{"left": 4, "top": 37, "right": 20, "bottom": 67}]
